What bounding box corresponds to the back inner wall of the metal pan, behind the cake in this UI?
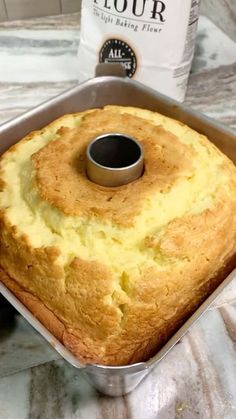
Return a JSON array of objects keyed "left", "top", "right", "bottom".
[{"left": 0, "top": 76, "right": 236, "bottom": 163}]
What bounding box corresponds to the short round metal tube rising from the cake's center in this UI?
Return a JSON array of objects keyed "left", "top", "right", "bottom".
[{"left": 86, "top": 133, "right": 144, "bottom": 187}]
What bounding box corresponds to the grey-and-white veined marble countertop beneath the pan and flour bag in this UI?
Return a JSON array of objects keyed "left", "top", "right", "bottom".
[{"left": 0, "top": 14, "right": 236, "bottom": 419}]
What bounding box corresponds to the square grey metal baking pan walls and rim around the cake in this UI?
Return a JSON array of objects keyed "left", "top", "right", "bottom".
[{"left": 0, "top": 67, "right": 236, "bottom": 396}]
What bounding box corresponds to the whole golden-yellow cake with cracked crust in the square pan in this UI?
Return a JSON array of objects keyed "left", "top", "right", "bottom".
[{"left": 0, "top": 106, "right": 236, "bottom": 365}]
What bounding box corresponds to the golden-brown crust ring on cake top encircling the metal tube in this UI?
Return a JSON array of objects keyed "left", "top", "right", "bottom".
[{"left": 32, "top": 110, "right": 194, "bottom": 226}]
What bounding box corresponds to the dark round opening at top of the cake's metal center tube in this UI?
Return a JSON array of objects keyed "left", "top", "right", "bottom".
[{"left": 88, "top": 134, "right": 142, "bottom": 169}]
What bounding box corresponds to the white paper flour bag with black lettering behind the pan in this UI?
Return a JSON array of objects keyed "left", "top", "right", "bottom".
[{"left": 79, "top": 0, "right": 200, "bottom": 101}]
